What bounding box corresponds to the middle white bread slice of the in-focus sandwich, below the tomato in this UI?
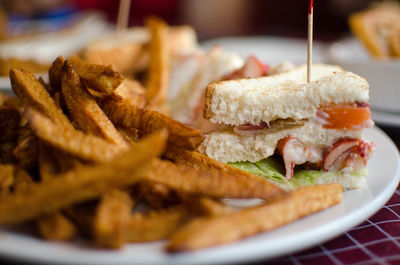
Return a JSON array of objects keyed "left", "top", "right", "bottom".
[{"left": 198, "top": 121, "right": 362, "bottom": 163}]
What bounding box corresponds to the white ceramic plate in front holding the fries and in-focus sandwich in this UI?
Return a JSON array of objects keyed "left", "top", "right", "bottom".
[{"left": 0, "top": 128, "right": 400, "bottom": 264}]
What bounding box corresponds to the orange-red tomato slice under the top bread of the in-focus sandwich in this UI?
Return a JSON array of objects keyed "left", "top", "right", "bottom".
[{"left": 317, "top": 104, "right": 371, "bottom": 130}]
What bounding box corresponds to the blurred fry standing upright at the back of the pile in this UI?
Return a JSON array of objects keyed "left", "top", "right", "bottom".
[{"left": 146, "top": 17, "right": 170, "bottom": 109}]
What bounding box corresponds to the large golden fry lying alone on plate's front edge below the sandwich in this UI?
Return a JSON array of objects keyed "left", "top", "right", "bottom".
[{"left": 167, "top": 184, "right": 343, "bottom": 252}]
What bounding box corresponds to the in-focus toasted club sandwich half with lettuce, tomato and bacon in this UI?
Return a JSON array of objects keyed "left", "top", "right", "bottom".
[{"left": 199, "top": 64, "right": 375, "bottom": 189}]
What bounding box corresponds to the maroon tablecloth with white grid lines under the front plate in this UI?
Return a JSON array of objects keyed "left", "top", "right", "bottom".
[{"left": 0, "top": 124, "right": 400, "bottom": 265}]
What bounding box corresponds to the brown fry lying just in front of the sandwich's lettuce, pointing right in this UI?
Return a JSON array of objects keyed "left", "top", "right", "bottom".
[{"left": 144, "top": 160, "right": 284, "bottom": 200}]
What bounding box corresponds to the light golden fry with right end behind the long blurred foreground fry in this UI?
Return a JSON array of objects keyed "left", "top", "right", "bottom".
[{"left": 24, "top": 108, "right": 122, "bottom": 162}]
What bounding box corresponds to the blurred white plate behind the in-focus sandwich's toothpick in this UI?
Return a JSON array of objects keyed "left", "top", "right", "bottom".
[{"left": 201, "top": 36, "right": 326, "bottom": 64}]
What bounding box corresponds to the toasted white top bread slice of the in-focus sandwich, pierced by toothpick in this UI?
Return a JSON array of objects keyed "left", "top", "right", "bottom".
[{"left": 203, "top": 64, "right": 369, "bottom": 125}]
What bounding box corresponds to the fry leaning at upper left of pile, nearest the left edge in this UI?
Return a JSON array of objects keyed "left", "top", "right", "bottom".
[{"left": 10, "top": 69, "right": 73, "bottom": 128}]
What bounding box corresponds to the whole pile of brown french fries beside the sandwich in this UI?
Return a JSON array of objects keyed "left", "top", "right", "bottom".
[{"left": 0, "top": 19, "right": 342, "bottom": 252}]
